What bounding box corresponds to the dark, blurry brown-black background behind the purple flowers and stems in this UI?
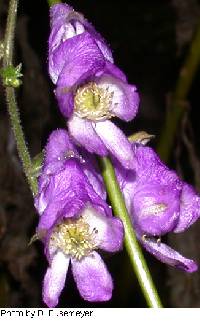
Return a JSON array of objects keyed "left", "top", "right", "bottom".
[{"left": 0, "top": 0, "right": 200, "bottom": 307}]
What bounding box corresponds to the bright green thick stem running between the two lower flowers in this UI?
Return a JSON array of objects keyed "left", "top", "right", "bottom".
[{"left": 100, "top": 157, "right": 162, "bottom": 308}]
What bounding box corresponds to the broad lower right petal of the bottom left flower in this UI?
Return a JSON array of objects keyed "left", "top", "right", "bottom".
[{"left": 72, "top": 252, "right": 113, "bottom": 302}]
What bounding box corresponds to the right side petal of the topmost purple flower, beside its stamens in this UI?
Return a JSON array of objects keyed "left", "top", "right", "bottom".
[{"left": 97, "top": 75, "right": 139, "bottom": 121}]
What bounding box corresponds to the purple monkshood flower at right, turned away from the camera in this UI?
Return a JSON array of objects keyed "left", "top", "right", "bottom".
[{"left": 114, "top": 144, "right": 200, "bottom": 272}]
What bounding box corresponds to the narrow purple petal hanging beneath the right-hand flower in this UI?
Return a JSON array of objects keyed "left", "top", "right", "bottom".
[{"left": 140, "top": 234, "right": 198, "bottom": 273}]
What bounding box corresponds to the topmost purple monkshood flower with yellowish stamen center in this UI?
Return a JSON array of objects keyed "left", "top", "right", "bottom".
[{"left": 49, "top": 4, "right": 139, "bottom": 168}]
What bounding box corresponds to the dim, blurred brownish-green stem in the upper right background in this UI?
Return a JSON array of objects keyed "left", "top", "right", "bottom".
[{"left": 157, "top": 25, "right": 200, "bottom": 162}]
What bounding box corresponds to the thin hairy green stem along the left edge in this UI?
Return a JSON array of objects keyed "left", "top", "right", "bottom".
[{"left": 3, "top": 0, "right": 37, "bottom": 195}]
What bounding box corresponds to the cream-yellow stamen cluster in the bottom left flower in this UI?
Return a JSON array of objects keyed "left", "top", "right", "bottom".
[{"left": 50, "top": 217, "right": 98, "bottom": 260}]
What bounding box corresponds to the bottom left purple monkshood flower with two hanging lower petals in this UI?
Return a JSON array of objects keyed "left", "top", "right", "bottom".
[{"left": 35, "top": 130, "right": 123, "bottom": 307}]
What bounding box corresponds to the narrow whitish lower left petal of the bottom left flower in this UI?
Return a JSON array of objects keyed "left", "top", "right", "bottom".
[{"left": 43, "top": 251, "right": 69, "bottom": 308}]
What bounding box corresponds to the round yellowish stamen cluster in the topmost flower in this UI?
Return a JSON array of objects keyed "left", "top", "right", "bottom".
[{"left": 74, "top": 82, "right": 113, "bottom": 121}]
